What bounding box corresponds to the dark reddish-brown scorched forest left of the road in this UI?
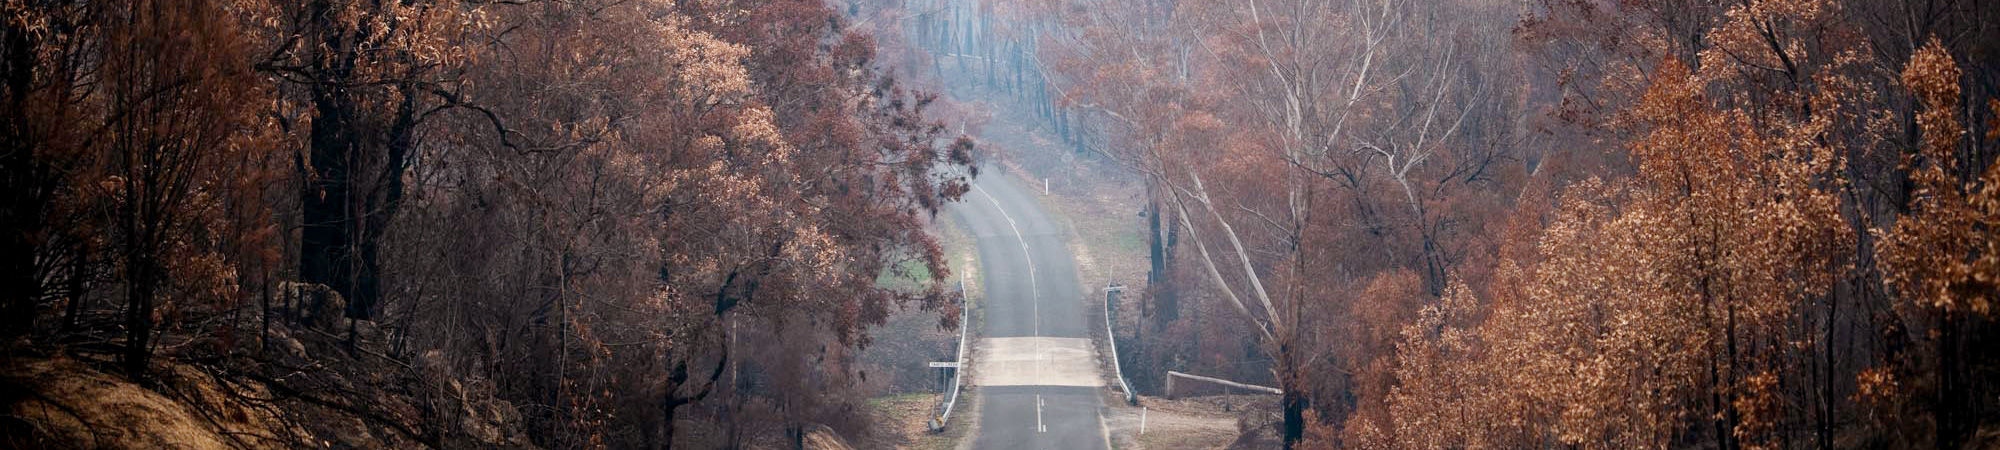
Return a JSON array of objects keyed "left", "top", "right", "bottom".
[{"left": 0, "top": 0, "right": 972, "bottom": 448}]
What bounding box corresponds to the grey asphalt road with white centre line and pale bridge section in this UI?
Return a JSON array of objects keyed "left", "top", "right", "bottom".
[{"left": 950, "top": 170, "right": 1108, "bottom": 450}]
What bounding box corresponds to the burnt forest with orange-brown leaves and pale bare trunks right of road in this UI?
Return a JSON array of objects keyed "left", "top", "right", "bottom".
[{"left": 956, "top": 0, "right": 2000, "bottom": 448}]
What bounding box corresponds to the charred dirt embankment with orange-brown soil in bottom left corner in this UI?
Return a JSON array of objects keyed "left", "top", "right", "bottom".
[{"left": 0, "top": 308, "right": 534, "bottom": 448}]
